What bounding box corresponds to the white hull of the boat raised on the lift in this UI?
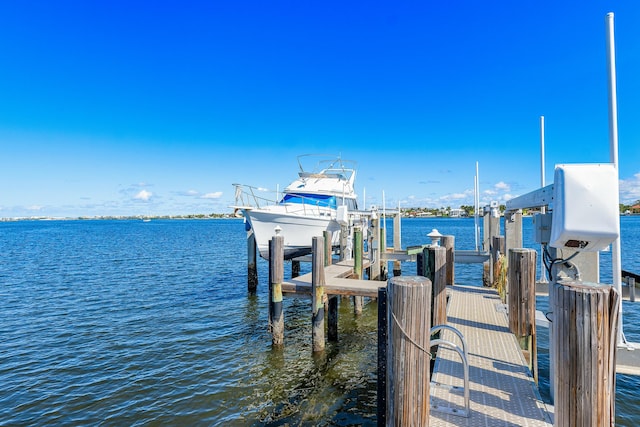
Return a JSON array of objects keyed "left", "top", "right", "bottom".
[{"left": 244, "top": 209, "right": 340, "bottom": 259}]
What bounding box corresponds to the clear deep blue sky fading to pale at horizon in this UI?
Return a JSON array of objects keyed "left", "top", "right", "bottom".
[{"left": 0, "top": 0, "right": 640, "bottom": 217}]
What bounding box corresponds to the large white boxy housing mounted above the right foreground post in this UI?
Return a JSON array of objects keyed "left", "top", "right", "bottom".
[{"left": 549, "top": 163, "right": 620, "bottom": 252}]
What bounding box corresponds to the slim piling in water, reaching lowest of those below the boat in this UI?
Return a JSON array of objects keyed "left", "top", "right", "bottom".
[{"left": 311, "top": 237, "right": 325, "bottom": 352}]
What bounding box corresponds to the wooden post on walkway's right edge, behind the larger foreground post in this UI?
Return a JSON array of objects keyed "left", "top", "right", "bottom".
[{"left": 508, "top": 248, "right": 538, "bottom": 382}]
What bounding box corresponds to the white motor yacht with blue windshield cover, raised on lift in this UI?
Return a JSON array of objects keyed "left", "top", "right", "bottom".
[{"left": 232, "top": 154, "right": 358, "bottom": 259}]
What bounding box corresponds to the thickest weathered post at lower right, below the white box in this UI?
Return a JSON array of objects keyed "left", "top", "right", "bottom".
[{"left": 552, "top": 280, "right": 620, "bottom": 427}]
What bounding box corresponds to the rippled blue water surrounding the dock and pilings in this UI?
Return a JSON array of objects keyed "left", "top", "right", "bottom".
[{"left": 0, "top": 217, "right": 640, "bottom": 426}]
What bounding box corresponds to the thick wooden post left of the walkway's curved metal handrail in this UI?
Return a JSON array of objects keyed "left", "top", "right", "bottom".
[{"left": 386, "top": 276, "right": 431, "bottom": 426}]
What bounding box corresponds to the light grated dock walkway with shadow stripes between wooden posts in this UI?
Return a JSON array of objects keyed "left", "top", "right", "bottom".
[{"left": 429, "top": 285, "right": 553, "bottom": 427}]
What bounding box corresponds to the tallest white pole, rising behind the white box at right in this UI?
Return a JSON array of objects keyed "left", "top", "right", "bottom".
[{"left": 605, "top": 12, "right": 626, "bottom": 345}]
